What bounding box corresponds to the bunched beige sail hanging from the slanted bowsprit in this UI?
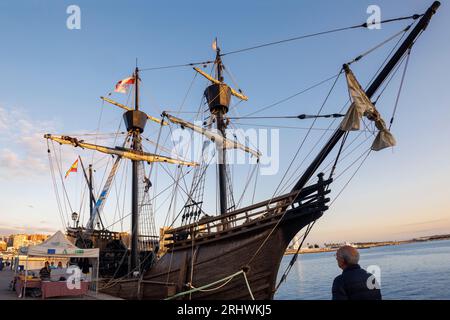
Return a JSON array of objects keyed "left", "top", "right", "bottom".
[{"left": 340, "top": 66, "right": 396, "bottom": 151}]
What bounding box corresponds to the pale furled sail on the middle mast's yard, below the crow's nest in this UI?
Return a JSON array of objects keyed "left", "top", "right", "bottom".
[{"left": 163, "top": 112, "right": 262, "bottom": 158}]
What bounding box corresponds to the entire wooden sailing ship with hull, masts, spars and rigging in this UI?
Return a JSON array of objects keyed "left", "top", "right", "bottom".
[{"left": 45, "top": 2, "right": 440, "bottom": 299}]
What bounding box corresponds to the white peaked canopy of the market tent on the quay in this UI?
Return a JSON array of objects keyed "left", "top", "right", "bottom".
[{"left": 28, "top": 231, "right": 99, "bottom": 258}]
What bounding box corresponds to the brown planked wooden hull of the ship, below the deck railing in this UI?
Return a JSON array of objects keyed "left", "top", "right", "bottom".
[{"left": 102, "top": 204, "right": 323, "bottom": 300}]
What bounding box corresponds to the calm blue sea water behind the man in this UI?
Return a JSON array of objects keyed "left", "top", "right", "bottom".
[{"left": 275, "top": 240, "right": 450, "bottom": 300}]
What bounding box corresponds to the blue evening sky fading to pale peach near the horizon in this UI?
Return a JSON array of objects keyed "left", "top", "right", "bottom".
[{"left": 0, "top": 0, "right": 450, "bottom": 243}]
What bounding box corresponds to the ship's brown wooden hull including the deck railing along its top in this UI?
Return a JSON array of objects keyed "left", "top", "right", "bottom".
[{"left": 101, "top": 175, "right": 332, "bottom": 300}]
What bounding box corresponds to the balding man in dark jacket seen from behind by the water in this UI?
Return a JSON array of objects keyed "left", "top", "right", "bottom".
[{"left": 332, "top": 246, "right": 381, "bottom": 300}]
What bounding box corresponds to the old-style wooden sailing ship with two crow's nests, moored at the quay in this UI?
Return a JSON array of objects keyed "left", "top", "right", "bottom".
[{"left": 45, "top": 2, "right": 440, "bottom": 299}]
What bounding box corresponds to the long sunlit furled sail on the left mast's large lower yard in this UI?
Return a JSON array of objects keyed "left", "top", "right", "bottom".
[{"left": 44, "top": 134, "right": 197, "bottom": 166}]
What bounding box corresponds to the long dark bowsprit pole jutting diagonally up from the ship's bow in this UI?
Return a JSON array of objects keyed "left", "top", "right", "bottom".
[{"left": 292, "top": 1, "right": 441, "bottom": 191}]
